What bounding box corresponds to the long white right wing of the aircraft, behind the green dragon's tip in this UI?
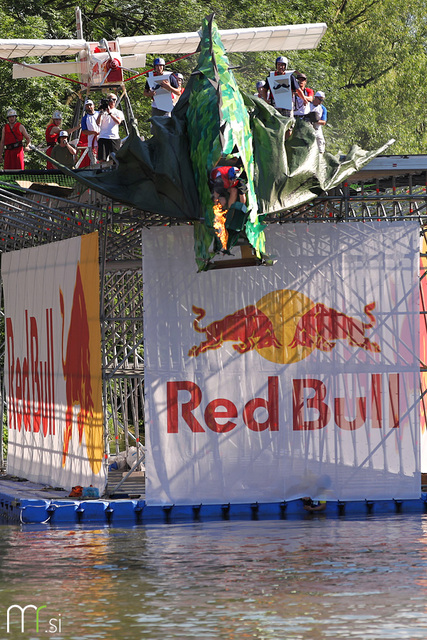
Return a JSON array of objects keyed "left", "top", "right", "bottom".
[{"left": 117, "top": 22, "right": 327, "bottom": 55}]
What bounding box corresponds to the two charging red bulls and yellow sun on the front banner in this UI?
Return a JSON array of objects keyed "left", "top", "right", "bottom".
[{"left": 188, "top": 289, "right": 381, "bottom": 364}]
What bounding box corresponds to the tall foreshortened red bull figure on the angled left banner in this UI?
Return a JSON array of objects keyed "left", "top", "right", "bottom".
[{"left": 59, "top": 265, "right": 94, "bottom": 466}]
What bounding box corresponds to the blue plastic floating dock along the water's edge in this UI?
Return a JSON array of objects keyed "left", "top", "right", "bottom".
[{"left": 0, "top": 476, "right": 427, "bottom": 527}]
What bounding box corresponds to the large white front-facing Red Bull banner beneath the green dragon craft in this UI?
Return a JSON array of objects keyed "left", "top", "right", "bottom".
[{"left": 143, "top": 222, "right": 421, "bottom": 505}]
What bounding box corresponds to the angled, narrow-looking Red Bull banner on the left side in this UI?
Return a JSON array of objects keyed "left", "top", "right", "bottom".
[{"left": 1, "top": 233, "right": 106, "bottom": 491}]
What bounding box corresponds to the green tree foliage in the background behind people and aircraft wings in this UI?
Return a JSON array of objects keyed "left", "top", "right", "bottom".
[{"left": 0, "top": 0, "right": 427, "bottom": 156}]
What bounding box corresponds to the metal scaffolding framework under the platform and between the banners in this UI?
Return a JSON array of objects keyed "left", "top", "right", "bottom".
[{"left": 0, "top": 156, "right": 427, "bottom": 480}]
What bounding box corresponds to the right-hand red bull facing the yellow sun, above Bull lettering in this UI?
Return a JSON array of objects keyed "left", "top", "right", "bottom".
[{"left": 289, "top": 302, "right": 381, "bottom": 353}]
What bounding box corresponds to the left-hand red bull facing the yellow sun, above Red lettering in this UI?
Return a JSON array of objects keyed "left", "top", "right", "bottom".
[{"left": 188, "top": 305, "right": 281, "bottom": 357}]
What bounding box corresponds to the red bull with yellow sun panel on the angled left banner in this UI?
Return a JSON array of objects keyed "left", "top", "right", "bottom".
[{"left": 59, "top": 234, "right": 103, "bottom": 473}]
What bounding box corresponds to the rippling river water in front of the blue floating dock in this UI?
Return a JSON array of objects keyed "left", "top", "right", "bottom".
[{"left": 0, "top": 515, "right": 427, "bottom": 640}]
